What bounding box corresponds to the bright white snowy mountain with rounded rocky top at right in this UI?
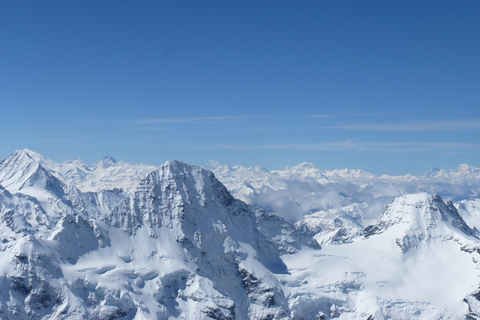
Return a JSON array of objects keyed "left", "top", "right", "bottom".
[{"left": 283, "top": 194, "right": 480, "bottom": 319}]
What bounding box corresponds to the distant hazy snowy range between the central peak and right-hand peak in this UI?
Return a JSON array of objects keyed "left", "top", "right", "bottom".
[{"left": 214, "top": 163, "right": 480, "bottom": 243}]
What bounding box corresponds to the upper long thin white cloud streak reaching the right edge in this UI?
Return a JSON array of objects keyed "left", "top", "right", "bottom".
[{"left": 329, "top": 119, "right": 480, "bottom": 132}]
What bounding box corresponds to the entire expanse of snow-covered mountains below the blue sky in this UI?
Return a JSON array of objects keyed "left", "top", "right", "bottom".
[{"left": 0, "top": 150, "right": 480, "bottom": 320}]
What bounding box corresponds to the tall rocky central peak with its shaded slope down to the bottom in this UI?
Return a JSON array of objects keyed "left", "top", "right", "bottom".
[{"left": 85, "top": 161, "right": 319, "bottom": 319}]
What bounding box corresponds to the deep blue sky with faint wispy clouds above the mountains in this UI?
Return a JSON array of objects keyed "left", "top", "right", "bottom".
[{"left": 0, "top": 0, "right": 480, "bottom": 174}]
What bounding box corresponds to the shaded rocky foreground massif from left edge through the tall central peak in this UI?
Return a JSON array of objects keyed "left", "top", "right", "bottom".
[{"left": 0, "top": 151, "right": 320, "bottom": 319}]
